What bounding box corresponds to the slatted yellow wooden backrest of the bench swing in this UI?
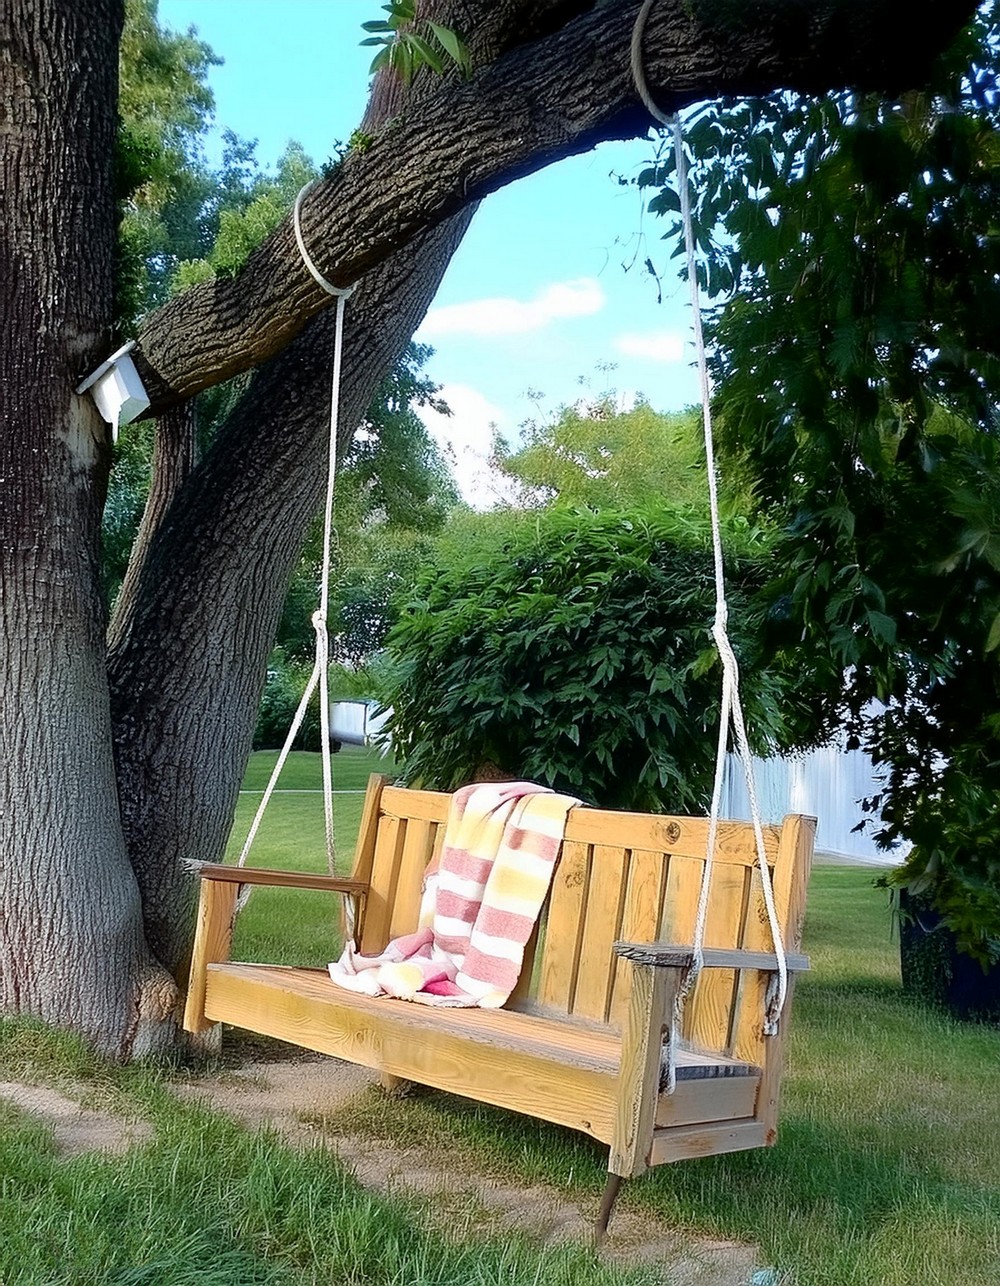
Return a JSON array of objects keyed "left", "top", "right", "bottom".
[{"left": 352, "top": 777, "right": 815, "bottom": 1065}]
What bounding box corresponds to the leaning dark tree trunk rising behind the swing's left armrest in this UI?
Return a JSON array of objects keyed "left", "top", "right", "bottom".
[{"left": 109, "top": 216, "right": 468, "bottom": 976}]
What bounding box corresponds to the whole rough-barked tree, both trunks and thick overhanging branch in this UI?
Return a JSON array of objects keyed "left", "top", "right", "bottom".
[{"left": 0, "top": 0, "right": 973, "bottom": 1053}]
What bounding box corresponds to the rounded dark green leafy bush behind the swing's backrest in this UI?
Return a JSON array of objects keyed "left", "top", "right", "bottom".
[{"left": 377, "top": 508, "right": 794, "bottom": 811}]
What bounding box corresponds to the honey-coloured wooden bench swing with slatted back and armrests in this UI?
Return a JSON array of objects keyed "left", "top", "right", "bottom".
[{"left": 184, "top": 775, "right": 815, "bottom": 1223}]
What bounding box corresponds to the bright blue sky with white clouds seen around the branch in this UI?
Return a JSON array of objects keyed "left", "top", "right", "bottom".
[{"left": 159, "top": 0, "right": 698, "bottom": 503}]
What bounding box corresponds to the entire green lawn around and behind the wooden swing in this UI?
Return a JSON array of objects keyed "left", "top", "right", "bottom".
[{"left": 0, "top": 747, "right": 1000, "bottom": 1286}]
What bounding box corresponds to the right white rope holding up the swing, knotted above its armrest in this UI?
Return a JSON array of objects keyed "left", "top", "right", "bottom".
[{"left": 631, "top": 0, "right": 788, "bottom": 1093}]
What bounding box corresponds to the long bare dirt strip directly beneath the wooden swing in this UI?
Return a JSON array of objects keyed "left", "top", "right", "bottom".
[{"left": 176, "top": 1057, "right": 758, "bottom": 1286}]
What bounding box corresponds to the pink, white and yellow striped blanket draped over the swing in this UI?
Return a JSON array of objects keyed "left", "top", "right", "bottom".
[{"left": 329, "top": 782, "right": 580, "bottom": 1008}]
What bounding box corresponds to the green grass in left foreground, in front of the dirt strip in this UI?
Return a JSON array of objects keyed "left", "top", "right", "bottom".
[{"left": 0, "top": 1022, "right": 650, "bottom": 1286}]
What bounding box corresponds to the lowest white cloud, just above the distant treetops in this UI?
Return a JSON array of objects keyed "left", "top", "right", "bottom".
[{"left": 415, "top": 385, "right": 519, "bottom": 509}]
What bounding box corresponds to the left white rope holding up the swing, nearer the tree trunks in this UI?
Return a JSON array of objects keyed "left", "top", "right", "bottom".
[{"left": 237, "top": 179, "right": 353, "bottom": 895}]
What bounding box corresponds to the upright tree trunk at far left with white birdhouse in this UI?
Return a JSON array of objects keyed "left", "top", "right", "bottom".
[{"left": 0, "top": 0, "right": 171, "bottom": 1053}]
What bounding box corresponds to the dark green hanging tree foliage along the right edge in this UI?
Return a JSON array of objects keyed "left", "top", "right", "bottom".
[{"left": 644, "top": 3, "right": 1000, "bottom": 957}]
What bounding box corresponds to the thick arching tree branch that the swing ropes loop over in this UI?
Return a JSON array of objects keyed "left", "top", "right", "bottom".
[{"left": 128, "top": 0, "right": 974, "bottom": 413}]
